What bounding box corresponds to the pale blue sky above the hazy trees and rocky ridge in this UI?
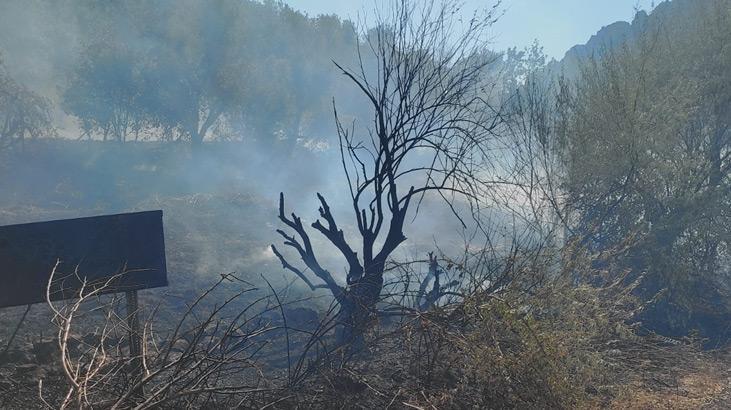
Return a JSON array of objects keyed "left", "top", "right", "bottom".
[{"left": 285, "top": 0, "right": 657, "bottom": 58}]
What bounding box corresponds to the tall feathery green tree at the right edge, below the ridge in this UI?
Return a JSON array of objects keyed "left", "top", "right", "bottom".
[{"left": 557, "top": 0, "right": 731, "bottom": 340}]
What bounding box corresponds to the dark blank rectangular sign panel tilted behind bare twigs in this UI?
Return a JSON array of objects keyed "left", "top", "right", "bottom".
[{"left": 0, "top": 211, "right": 168, "bottom": 307}]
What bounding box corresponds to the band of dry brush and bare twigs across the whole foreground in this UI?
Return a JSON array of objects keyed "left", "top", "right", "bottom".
[{"left": 0, "top": 223, "right": 731, "bottom": 408}]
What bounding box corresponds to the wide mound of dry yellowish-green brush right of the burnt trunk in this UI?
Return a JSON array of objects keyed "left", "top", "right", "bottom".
[{"left": 289, "top": 255, "right": 717, "bottom": 408}]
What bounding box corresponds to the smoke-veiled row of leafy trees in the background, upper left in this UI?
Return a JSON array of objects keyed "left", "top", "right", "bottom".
[{"left": 62, "top": 0, "right": 357, "bottom": 144}]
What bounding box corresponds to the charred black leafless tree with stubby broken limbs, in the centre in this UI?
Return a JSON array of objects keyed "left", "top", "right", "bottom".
[{"left": 272, "top": 1, "right": 506, "bottom": 342}]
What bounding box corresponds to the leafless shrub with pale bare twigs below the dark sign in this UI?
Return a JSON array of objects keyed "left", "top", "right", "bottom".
[{"left": 38, "top": 268, "right": 282, "bottom": 409}]
